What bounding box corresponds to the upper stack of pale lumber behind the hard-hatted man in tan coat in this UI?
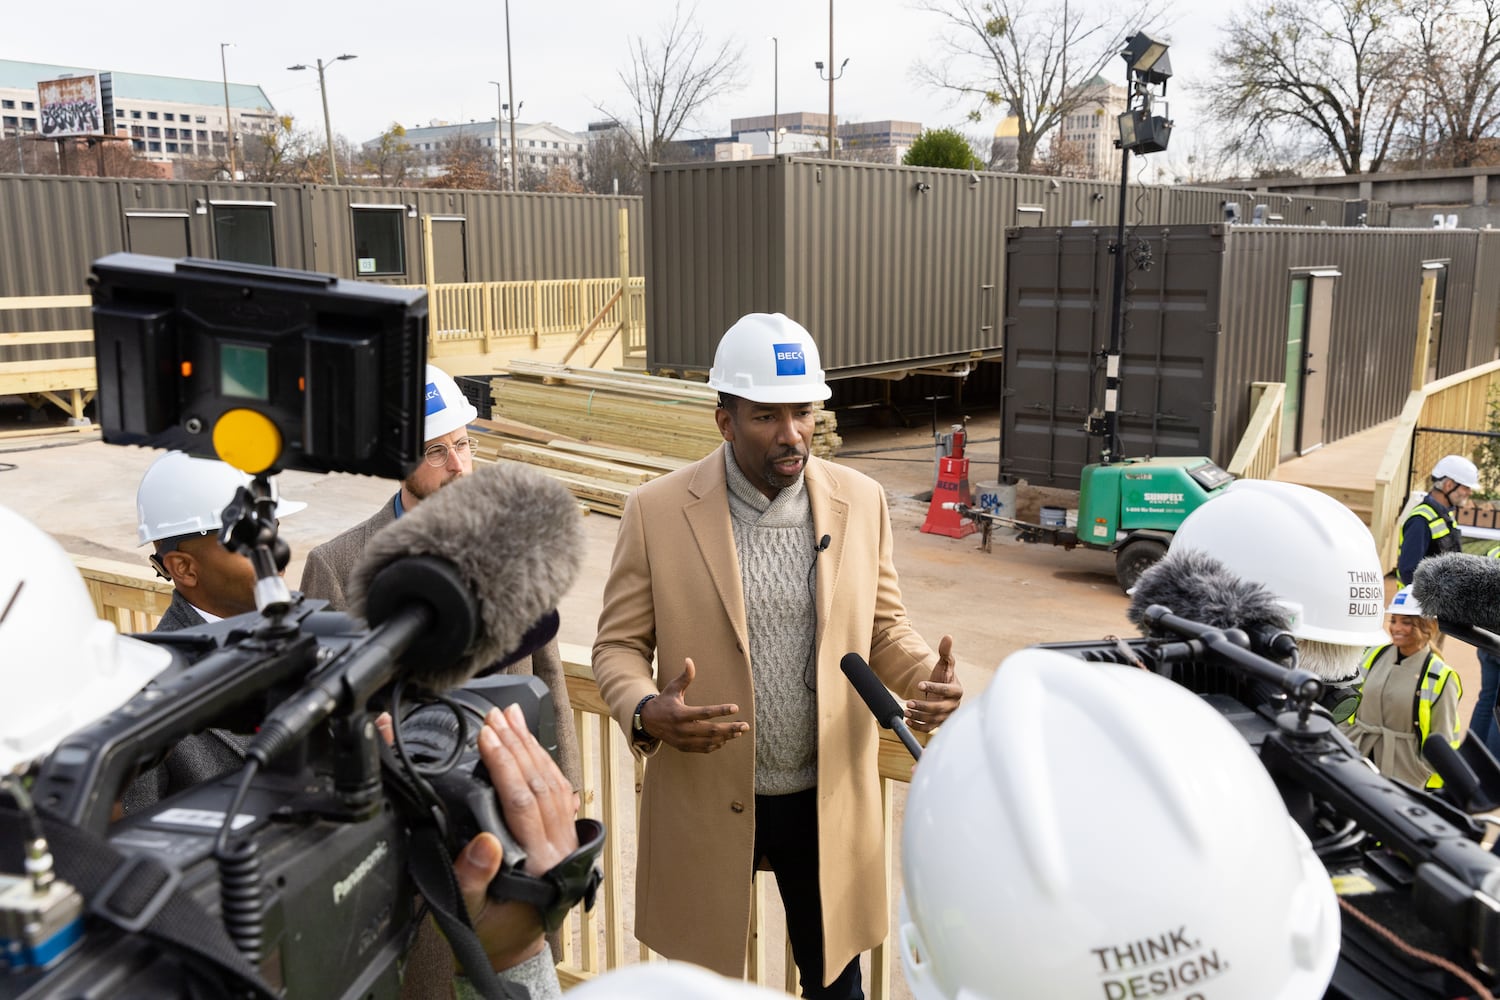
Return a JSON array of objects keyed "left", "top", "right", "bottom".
[{"left": 492, "top": 360, "right": 840, "bottom": 462}]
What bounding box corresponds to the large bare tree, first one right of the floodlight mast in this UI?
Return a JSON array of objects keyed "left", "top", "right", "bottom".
[{"left": 1205, "top": 0, "right": 1415, "bottom": 174}]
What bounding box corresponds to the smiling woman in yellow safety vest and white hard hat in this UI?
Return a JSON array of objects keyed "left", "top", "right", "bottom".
[{"left": 1344, "top": 588, "right": 1464, "bottom": 789}]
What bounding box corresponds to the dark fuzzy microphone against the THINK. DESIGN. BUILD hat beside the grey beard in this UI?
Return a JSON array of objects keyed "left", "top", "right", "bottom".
[{"left": 1125, "top": 549, "right": 1298, "bottom": 661}]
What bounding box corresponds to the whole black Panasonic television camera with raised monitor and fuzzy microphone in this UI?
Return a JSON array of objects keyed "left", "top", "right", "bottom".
[{"left": 0, "top": 253, "right": 605, "bottom": 999}]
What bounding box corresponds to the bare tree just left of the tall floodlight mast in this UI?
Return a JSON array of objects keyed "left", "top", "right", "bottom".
[{"left": 917, "top": 0, "right": 1163, "bottom": 174}]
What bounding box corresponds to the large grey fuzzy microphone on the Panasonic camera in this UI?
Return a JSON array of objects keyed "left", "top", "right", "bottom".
[{"left": 350, "top": 462, "right": 582, "bottom": 691}]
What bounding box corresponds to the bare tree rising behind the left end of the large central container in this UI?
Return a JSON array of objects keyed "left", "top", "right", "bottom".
[{"left": 597, "top": 3, "right": 744, "bottom": 172}]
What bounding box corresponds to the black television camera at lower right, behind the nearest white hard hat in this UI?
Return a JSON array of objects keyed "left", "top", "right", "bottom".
[{"left": 1040, "top": 604, "right": 1500, "bottom": 1000}]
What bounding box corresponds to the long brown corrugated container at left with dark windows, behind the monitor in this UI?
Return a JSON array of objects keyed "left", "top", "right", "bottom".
[{"left": 0, "top": 174, "right": 645, "bottom": 340}]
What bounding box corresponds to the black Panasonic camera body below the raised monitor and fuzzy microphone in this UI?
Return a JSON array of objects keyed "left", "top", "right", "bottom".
[{"left": 0, "top": 601, "right": 557, "bottom": 1000}]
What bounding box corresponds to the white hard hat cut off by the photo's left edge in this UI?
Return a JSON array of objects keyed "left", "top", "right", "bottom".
[{"left": 0, "top": 507, "right": 171, "bottom": 774}]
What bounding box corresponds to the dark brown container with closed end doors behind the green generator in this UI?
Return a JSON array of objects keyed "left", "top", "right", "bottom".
[{"left": 1001, "top": 225, "right": 1500, "bottom": 489}]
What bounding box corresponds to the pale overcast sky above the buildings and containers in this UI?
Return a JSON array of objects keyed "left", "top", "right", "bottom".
[{"left": 11, "top": 0, "right": 1221, "bottom": 173}]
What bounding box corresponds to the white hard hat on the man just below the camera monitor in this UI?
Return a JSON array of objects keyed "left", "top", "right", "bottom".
[{"left": 135, "top": 451, "right": 306, "bottom": 546}]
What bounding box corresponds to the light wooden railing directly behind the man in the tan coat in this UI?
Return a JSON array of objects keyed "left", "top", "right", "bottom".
[{"left": 74, "top": 556, "right": 923, "bottom": 1000}]
